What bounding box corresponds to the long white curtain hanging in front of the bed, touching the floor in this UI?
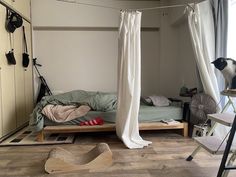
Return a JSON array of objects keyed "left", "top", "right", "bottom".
[{"left": 116, "top": 11, "right": 151, "bottom": 149}]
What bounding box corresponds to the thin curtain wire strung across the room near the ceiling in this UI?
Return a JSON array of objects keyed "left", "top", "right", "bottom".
[{"left": 57, "top": 0, "right": 194, "bottom": 11}]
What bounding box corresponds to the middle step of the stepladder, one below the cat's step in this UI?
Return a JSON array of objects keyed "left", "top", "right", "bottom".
[{"left": 207, "top": 113, "right": 235, "bottom": 127}]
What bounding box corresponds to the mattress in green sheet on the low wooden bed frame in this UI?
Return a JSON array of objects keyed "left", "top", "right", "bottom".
[{"left": 44, "top": 105, "right": 183, "bottom": 126}]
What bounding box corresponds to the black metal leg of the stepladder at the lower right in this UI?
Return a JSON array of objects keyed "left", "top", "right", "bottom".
[{"left": 217, "top": 115, "right": 236, "bottom": 177}]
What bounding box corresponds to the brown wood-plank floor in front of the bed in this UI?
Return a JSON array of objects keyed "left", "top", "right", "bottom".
[{"left": 0, "top": 131, "right": 236, "bottom": 177}]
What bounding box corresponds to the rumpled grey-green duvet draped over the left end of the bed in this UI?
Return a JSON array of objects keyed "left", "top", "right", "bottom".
[{"left": 29, "top": 90, "right": 117, "bottom": 131}]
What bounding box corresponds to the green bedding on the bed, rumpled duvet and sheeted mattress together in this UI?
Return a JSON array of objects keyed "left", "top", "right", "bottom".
[{"left": 29, "top": 90, "right": 182, "bottom": 131}]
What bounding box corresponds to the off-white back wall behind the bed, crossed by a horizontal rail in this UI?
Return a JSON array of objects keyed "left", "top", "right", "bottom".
[{"left": 32, "top": 0, "right": 160, "bottom": 94}]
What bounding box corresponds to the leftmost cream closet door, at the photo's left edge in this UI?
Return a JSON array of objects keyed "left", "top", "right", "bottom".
[{"left": 0, "top": 6, "right": 16, "bottom": 135}]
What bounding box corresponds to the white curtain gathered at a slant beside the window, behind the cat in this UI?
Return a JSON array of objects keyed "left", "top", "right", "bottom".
[{"left": 187, "top": 0, "right": 220, "bottom": 106}]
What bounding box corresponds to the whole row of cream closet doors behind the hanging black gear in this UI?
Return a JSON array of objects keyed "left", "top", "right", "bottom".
[{"left": 0, "top": 0, "right": 33, "bottom": 137}]
